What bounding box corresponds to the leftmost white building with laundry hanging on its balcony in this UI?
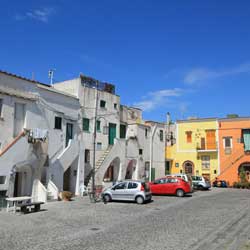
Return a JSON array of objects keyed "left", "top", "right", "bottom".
[{"left": 0, "top": 71, "right": 84, "bottom": 201}]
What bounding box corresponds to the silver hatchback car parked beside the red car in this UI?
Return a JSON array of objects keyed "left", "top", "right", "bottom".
[{"left": 102, "top": 180, "right": 152, "bottom": 204}]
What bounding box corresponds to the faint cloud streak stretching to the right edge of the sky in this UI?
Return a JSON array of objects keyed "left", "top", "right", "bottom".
[{"left": 184, "top": 63, "right": 250, "bottom": 85}]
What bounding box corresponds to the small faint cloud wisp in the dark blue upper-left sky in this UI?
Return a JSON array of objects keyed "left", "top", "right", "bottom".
[{"left": 15, "top": 8, "right": 54, "bottom": 23}]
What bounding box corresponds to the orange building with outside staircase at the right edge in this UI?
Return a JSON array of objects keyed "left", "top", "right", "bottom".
[{"left": 218, "top": 117, "right": 250, "bottom": 185}]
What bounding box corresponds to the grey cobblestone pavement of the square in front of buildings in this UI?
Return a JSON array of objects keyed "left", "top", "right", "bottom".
[{"left": 0, "top": 189, "right": 250, "bottom": 250}]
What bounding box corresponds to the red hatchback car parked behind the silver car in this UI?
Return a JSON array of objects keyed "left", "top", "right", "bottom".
[{"left": 149, "top": 177, "right": 192, "bottom": 197}]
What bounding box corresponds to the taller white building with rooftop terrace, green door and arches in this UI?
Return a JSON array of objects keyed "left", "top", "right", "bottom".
[{"left": 55, "top": 75, "right": 165, "bottom": 186}]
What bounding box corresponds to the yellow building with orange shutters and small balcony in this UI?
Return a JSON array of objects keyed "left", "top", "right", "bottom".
[{"left": 165, "top": 118, "right": 219, "bottom": 180}]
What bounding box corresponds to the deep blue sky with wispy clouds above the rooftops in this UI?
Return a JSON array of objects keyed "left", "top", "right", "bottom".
[{"left": 0, "top": 0, "right": 250, "bottom": 121}]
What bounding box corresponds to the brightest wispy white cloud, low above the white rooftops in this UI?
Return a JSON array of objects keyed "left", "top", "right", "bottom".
[{"left": 133, "top": 88, "right": 183, "bottom": 111}]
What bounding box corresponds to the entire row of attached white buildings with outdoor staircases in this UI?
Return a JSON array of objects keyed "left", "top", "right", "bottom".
[{"left": 0, "top": 71, "right": 165, "bottom": 201}]
